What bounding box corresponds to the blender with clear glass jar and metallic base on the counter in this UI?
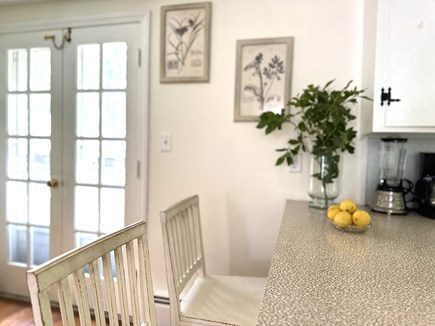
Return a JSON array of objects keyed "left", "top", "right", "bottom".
[{"left": 372, "top": 138, "right": 408, "bottom": 214}]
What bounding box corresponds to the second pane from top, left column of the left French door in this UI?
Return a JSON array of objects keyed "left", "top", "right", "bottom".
[{"left": 8, "top": 94, "right": 29, "bottom": 136}]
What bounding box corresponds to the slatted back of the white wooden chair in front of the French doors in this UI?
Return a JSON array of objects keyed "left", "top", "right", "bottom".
[{"left": 27, "top": 221, "right": 156, "bottom": 326}]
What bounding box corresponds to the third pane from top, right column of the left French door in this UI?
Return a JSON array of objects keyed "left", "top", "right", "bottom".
[{"left": 29, "top": 139, "right": 51, "bottom": 181}]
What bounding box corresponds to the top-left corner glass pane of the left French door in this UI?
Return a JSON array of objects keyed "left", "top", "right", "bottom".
[{"left": 8, "top": 49, "right": 27, "bottom": 92}]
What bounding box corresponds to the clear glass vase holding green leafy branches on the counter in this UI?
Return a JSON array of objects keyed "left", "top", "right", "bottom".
[{"left": 308, "top": 154, "right": 340, "bottom": 209}]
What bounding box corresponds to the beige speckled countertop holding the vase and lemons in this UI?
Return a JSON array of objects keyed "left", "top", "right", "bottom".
[{"left": 258, "top": 200, "right": 435, "bottom": 326}]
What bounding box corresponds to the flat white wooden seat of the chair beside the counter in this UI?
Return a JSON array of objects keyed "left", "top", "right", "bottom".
[{"left": 181, "top": 275, "right": 266, "bottom": 325}]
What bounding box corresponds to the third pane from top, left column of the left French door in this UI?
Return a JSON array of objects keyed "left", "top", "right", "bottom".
[{"left": 7, "top": 138, "right": 28, "bottom": 180}]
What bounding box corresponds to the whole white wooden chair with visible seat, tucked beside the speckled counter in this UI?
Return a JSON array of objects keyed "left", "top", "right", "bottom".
[{"left": 160, "top": 195, "right": 266, "bottom": 326}]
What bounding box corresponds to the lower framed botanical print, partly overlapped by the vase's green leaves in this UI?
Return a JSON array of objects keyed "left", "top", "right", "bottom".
[{"left": 234, "top": 36, "right": 294, "bottom": 122}]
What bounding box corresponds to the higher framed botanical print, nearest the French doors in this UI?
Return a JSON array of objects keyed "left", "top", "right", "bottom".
[{"left": 160, "top": 2, "right": 212, "bottom": 83}]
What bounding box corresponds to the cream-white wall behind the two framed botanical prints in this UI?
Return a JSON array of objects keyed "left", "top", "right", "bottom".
[{"left": 0, "top": 0, "right": 365, "bottom": 296}]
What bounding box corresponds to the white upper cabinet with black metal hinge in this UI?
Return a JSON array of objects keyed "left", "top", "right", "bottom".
[{"left": 362, "top": 0, "right": 435, "bottom": 133}]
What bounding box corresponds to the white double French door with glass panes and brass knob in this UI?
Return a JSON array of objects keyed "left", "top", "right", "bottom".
[{"left": 0, "top": 17, "right": 147, "bottom": 296}]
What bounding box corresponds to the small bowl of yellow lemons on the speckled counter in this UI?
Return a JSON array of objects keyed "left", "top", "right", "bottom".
[{"left": 326, "top": 199, "right": 372, "bottom": 233}]
